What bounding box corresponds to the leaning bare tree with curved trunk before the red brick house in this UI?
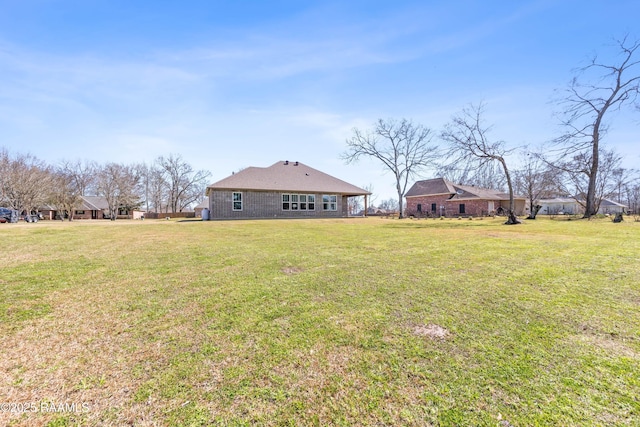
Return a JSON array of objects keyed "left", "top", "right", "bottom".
[{"left": 442, "top": 103, "right": 520, "bottom": 224}]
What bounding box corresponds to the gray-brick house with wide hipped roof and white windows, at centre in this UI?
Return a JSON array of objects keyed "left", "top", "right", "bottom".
[{"left": 206, "top": 161, "right": 371, "bottom": 219}]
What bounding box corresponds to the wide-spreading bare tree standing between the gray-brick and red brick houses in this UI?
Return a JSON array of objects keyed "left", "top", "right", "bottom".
[{"left": 341, "top": 119, "right": 436, "bottom": 218}]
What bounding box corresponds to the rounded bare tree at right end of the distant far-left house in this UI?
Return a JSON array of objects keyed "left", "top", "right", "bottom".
[{"left": 97, "top": 163, "right": 140, "bottom": 221}]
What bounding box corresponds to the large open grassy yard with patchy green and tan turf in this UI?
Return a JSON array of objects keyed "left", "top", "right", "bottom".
[{"left": 0, "top": 218, "right": 640, "bottom": 427}]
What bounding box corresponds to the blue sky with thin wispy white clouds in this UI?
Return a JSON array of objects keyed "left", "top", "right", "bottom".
[{"left": 0, "top": 0, "right": 640, "bottom": 200}]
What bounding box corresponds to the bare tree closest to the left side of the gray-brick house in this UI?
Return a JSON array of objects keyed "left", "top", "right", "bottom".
[{"left": 156, "top": 154, "right": 211, "bottom": 212}]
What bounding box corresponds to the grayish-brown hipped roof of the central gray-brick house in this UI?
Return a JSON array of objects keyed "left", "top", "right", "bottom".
[{"left": 207, "top": 161, "right": 371, "bottom": 196}]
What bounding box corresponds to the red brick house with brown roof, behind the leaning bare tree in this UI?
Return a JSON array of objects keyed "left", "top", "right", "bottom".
[{"left": 405, "top": 178, "right": 527, "bottom": 217}]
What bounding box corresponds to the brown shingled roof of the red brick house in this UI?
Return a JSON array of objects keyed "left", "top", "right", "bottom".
[{"left": 405, "top": 178, "right": 524, "bottom": 200}]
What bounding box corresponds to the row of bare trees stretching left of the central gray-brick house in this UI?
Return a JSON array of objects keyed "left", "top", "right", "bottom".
[{"left": 0, "top": 147, "right": 211, "bottom": 220}]
